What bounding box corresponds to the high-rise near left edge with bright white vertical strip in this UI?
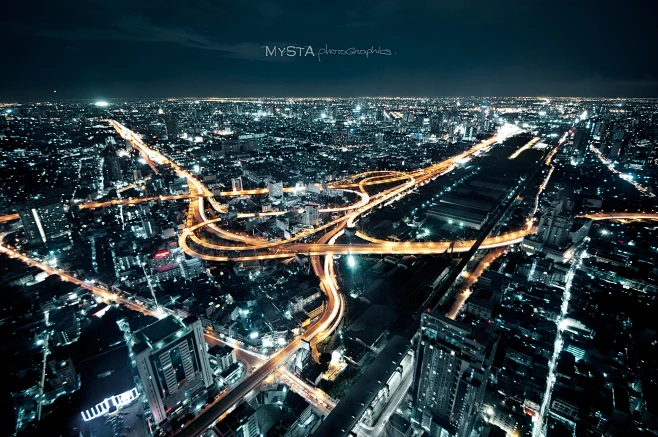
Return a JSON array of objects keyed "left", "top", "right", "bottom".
[{"left": 16, "top": 200, "right": 69, "bottom": 244}]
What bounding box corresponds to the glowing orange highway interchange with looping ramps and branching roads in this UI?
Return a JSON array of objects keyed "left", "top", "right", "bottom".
[{"left": 0, "top": 120, "right": 658, "bottom": 436}]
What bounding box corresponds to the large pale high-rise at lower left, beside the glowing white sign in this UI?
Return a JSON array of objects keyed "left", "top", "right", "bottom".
[{"left": 133, "top": 316, "right": 213, "bottom": 424}]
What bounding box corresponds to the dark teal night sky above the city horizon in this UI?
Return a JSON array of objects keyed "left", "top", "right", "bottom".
[{"left": 0, "top": 0, "right": 658, "bottom": 101}]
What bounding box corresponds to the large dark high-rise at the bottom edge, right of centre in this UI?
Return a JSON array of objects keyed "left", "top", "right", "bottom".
[{"left": 412, "top": 312, "right": 497, "bottom": 437}]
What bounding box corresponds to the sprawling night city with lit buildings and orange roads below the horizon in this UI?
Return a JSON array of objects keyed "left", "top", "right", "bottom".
[{"left": 0, "top": 98, "right": 658, "bottom": 436}]
